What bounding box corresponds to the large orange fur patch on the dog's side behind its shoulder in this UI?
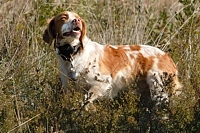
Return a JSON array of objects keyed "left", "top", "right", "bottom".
[{"left": 99, "top": 45, "right": 128, "bottom": 77}]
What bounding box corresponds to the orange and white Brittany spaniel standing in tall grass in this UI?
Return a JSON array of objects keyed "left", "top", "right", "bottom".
[{"left": 43, "top": 11, "right": 181, "bottom": 110}]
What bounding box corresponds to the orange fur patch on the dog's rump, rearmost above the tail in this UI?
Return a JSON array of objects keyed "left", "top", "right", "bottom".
[{"left": 158, "top": 54, "right": 177, "bottom": 74}]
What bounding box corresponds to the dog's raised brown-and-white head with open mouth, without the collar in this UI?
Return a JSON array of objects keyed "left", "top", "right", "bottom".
[{"left": 43, "top": 11, "right": 86, "bottom": 47}]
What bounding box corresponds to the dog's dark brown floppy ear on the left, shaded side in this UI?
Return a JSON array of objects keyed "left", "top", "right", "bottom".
[{"left": 43, "top": 19, "right": 56, "bottom": 44}]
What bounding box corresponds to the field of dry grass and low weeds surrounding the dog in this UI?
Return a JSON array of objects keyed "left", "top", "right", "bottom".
[{"left": 0, "top": 0, "right": 200, "bottom": 133}]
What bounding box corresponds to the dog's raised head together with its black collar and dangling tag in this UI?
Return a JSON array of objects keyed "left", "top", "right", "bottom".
[{"left": 43, "top": 11, "right": 86, "bottom": 80}]
